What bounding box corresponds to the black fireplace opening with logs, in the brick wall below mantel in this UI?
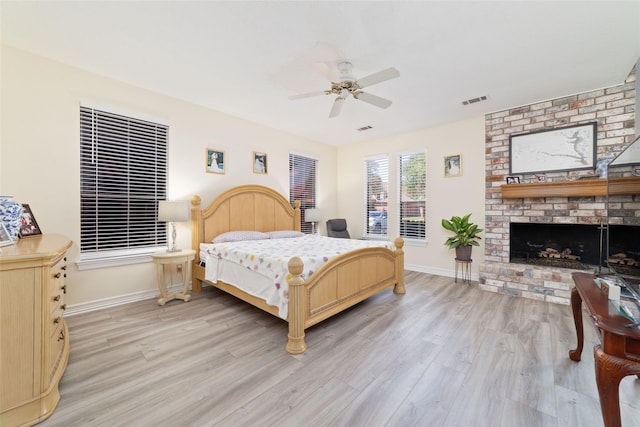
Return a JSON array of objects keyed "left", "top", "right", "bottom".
[{"left": 509, "top": 223, "right": 640, "bottom": 276}]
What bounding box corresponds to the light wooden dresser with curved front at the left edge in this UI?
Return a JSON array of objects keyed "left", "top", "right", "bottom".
[{"left": 0, "top": 234, "right": 71, "bottom": 427}]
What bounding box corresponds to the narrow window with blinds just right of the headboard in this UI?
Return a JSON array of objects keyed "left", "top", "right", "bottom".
[{"left": 289, "top": 154, "right": 318, "bottom": 234}]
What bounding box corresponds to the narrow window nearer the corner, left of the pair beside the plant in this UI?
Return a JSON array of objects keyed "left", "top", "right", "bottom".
[{"left": 365, "top": 157, "right": 389, "bottom": 236}]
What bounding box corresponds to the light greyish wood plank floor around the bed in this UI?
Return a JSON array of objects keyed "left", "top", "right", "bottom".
[{"left": 41, "top": 272, "right": 640, "bottom": 427}]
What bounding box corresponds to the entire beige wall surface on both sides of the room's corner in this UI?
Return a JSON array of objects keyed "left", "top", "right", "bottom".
[{"left": 0, "top": 46, "right": 484, "bottom": 310}]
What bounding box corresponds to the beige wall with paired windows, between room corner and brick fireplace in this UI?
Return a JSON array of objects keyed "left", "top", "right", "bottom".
[{"left": 337, "top": 117, "right": 485, "bottom": 277}]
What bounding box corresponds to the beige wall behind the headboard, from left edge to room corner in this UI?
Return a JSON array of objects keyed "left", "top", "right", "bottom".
[{"left": 0, "top": 46, "right": 337, "bottom": 308}]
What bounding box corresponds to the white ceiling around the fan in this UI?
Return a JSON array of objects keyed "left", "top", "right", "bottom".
[{"left": 0, "top": 0, "right": 640, "bottom": 146}]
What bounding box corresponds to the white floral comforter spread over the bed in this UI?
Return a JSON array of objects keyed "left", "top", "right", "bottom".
[{"left": 200, "top": 235, "right": 393, "bottom": 319}]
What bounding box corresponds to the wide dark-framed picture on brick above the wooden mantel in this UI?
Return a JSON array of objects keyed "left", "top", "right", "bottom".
[{"left": 509, "top": 122, "right": 596, "bottom": 174}]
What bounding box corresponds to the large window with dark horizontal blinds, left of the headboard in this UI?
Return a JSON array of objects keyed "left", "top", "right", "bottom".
[{"left": 80, "top": 106, "right": 168, "bottom": 259}]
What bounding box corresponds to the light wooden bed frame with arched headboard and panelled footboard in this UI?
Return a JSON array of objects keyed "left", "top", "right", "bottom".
[{"left": 191, "top": 185, "right": 405, "bottom": 354}]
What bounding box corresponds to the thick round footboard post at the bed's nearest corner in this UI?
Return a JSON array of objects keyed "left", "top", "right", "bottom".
[{"left": 286, "top": 257, "right": 307, "bottom": 354}]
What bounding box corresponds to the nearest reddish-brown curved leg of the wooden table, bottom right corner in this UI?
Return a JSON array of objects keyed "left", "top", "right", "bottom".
[{"left": 593, "top": 345, "right": 640, "bottom": 427}]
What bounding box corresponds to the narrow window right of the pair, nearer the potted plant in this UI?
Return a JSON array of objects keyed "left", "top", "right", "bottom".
[{"left": 398, "top": 152, "right": 427, "bottom": 240}]
